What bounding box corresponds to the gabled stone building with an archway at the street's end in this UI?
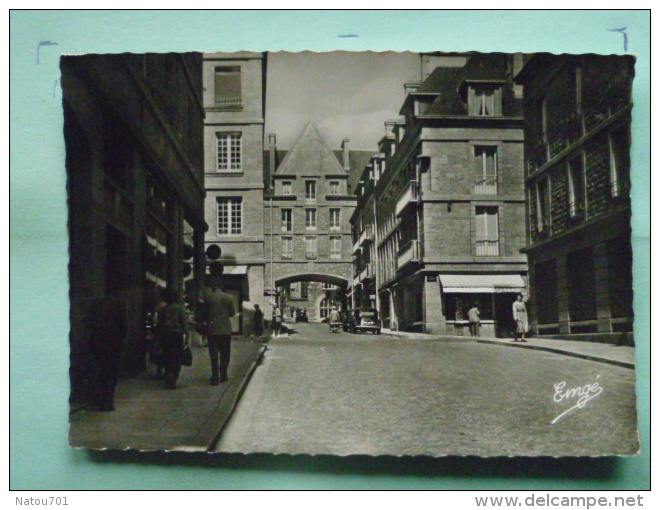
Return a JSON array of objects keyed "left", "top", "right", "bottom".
[{"left": 263, "top": 124, "right": 364, "bottom": 320}]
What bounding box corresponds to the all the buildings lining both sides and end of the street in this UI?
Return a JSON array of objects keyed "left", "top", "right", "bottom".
[{"left": 61, "top": 52, "right": 634, "bottom": 401}]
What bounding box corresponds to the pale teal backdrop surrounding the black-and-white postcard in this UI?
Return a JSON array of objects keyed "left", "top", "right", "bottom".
[{"left": 10, "top": 11, "right": 650, "bottom": 490}]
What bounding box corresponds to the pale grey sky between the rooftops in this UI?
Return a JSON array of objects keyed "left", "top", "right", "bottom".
[{"left": 265, "top": 51, "right": 420, "bottom": 151}]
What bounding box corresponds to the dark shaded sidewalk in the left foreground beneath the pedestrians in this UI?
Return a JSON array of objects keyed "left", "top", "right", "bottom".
[{"left": 69, "top": 338, "right": 266, "bottom": 451}]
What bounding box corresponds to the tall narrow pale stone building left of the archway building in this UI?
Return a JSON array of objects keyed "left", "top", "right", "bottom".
[{"left": 203, "top": 52, "right": 267, "bottom": 333}]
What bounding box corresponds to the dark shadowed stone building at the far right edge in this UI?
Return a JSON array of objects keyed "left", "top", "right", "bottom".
[{"left": 516, "top": 54, "right": 634, "bottom": 341}]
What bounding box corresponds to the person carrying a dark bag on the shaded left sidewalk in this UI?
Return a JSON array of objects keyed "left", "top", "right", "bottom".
[{"left": 158, "top": 289, "right": 188, "bottom": 390}]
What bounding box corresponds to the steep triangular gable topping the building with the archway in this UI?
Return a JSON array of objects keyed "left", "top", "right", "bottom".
[{"left": 275, "top": 122, "right": 346, "bottom": 175}]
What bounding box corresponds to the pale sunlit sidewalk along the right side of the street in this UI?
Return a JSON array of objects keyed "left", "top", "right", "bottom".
[{"left": 382, "top": 329, "right": 635, "bottom": 369}]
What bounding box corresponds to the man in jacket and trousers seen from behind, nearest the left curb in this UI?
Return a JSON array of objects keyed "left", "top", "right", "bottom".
[{"left": 204, "top": 262, "right": 236, "bottom": 386}]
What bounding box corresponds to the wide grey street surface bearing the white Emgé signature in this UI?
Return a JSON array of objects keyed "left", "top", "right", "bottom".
[{"left": 216, "top": 324, "right": 638, "bottom": 456}]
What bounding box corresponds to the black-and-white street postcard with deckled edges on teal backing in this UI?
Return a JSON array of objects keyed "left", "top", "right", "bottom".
[{"left": 60, "top": 50, "right": 640, "bottom": 457}]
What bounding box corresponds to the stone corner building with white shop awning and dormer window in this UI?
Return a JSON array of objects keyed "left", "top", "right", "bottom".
[{"left": 352, "top": 53, "right": 527, "bottom": 336}]
